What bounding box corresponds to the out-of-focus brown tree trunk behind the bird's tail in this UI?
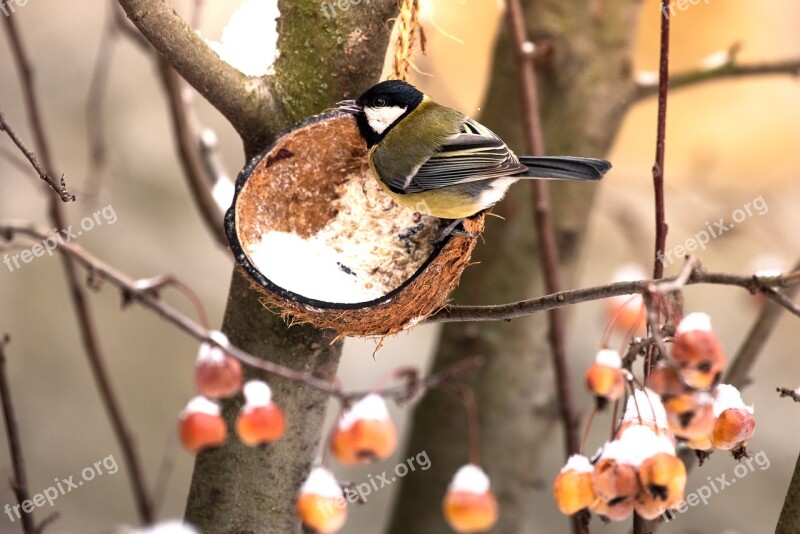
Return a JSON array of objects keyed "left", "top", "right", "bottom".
[{"left": 389, "top": 0, "right": 639, "bottom": 534}]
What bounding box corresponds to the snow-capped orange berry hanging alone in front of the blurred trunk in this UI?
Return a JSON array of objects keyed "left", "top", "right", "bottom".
[{"left": 442, "top": 464, "right": 498, "bottom": 532}]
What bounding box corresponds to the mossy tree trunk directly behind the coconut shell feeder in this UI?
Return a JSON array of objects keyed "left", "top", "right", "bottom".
[{"left": 177, "top": 0, "right": 398, "bottom": 534}]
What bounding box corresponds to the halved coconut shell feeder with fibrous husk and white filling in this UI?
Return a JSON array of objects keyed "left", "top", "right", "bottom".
[{"left": 225, "top": 111, "right": 484, "bottom": 336}]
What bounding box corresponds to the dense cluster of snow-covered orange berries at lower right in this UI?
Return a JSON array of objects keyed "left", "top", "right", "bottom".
[{"left": 553, "top": 313, "right": 755, "bottom": 521}]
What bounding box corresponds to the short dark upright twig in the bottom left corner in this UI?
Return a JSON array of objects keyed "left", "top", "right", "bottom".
[{"left": 0, "top": 334, "right": 37, "bottom": 534}]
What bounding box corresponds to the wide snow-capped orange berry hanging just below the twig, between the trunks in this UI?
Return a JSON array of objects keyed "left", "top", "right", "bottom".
[{"left": 331, "top": 394, "right": 397, "bottom": 465}]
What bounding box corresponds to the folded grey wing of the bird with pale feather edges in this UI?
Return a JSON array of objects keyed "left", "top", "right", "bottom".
[{"left": 387, "top": 118, "right": 527, "bottom": 193}]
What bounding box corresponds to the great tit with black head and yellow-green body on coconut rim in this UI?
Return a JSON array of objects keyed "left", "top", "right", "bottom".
[{"left": 338, "top": 80, "right": 611, "bottom": 238}]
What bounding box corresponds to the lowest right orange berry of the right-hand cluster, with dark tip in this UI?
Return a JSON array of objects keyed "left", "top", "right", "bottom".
[{"left": 635, "top": 452, "right": 686, "bottom": 519}]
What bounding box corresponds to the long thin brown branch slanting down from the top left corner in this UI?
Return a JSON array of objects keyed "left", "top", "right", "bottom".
[{"left": 4, "top": 17, "right": 154, "bottom": 524}]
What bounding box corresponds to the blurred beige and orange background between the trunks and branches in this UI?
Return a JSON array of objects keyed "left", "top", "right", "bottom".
[{"left": 0, "top": 0, "right": 800, "bottom": 533}]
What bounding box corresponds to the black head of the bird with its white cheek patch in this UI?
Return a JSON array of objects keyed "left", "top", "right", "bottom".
[{"left": 355, "top": 80, "right": 425, "bottom": 147}]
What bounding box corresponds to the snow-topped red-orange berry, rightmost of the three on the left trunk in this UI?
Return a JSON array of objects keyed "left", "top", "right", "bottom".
[{"left": 236, "top": 380, "right": 286, "bottom": 447}]
